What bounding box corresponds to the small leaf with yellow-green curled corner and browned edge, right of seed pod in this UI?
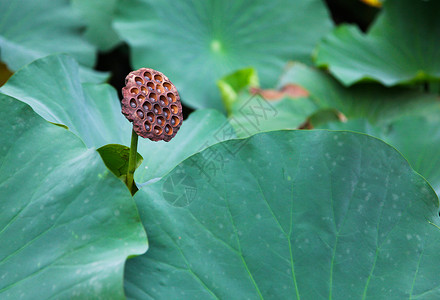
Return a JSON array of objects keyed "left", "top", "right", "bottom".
[{"left": 217, "top": 69, "right": 318, "bottom": 137}]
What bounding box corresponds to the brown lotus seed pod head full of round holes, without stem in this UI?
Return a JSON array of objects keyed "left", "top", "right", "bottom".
[{"left": 122, "top": 68, "right": 183, "bottom": 142}]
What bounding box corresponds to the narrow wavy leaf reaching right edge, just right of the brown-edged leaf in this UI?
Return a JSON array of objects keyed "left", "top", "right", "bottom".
[{"left": 280, "top": 64, "right": 440, "bottom": 123}]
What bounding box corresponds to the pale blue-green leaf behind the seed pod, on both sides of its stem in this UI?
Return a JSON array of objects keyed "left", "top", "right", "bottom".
[{"left": 0, "top": 55, "right": 235, "bottom": 183}]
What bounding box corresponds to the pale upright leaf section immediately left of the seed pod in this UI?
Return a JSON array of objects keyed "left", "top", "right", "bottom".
[{"left": 0, "top": 55, "right": 131, "bottom": 148}]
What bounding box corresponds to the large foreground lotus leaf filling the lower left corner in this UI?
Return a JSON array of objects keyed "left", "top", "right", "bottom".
[{"left": 0, "top": 95, "right": 147, "bottom": 299}]
